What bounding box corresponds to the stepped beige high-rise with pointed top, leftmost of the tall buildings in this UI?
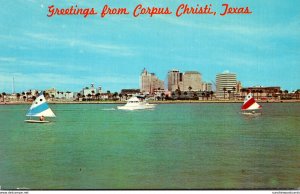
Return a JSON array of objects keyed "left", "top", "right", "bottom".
[{"left": 140, "top": 68, "right": 164, "bottom": 94}]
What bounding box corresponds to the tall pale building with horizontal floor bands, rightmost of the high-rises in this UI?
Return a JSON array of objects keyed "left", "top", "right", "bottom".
[{"left": 216, "top": 71, "right": 237, "bottom": 97}]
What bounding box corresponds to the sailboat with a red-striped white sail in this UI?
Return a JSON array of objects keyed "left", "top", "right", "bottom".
[{"left": 241, "top": 92, "right": 262, "bottom": 115}]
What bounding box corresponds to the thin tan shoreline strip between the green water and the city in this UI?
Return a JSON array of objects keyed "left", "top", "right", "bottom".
[{"left": 0, "top": 99, "right": 300, "bottom": 105}]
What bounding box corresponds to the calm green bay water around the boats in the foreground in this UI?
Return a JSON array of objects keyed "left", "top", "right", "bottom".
[{"left": 0, "top": 103, "right": 300, "bottom": 189}]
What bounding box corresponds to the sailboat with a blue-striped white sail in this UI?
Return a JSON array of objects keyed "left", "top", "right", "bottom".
[{"left": 25, "top": 93, "right": 55, "bottom": 123}]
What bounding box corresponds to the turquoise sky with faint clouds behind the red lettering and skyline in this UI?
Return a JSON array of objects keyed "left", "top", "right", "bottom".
[{"left": 0, "top": 0, "right": 300, "bottom": 93}]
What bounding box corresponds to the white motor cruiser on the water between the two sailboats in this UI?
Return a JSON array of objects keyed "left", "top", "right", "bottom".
[{"left": 117, "top": 96, "right": 156, "bottom": 110}]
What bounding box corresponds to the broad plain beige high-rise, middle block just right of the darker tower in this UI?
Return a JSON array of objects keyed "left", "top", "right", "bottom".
[{"left": 182, "top": 71, "right": 202, "bottom": 91}]
